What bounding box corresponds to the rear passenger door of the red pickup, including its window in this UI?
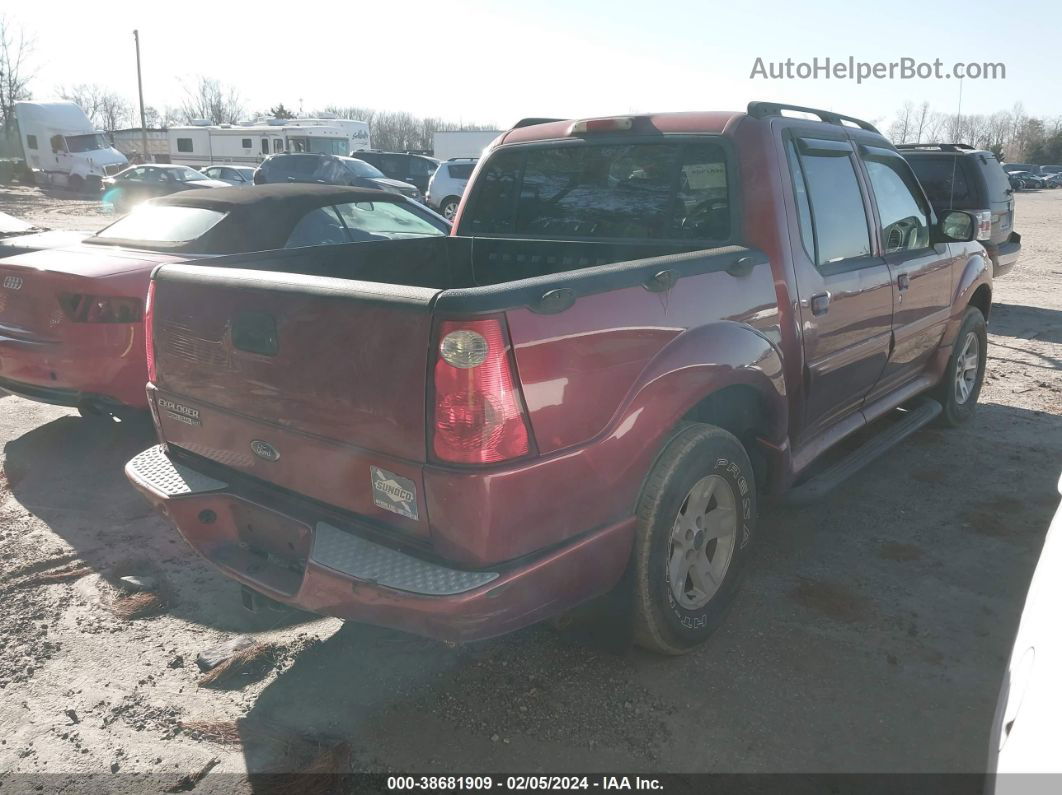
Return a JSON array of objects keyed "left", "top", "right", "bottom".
[{"left": 784, "top": 128, "right": 892, "bottom": 439}]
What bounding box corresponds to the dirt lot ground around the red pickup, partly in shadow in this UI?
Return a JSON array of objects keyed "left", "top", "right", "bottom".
[{"left": 0, "top": 182, "right": 1062, "bottom": 791}]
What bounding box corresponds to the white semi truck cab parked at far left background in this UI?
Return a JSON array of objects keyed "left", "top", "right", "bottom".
[{"left": 15, "top": 101, "right": 129, "bottom": 192}]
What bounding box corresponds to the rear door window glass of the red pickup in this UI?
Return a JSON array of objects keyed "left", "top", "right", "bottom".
[{"left": 798, "top": 140, "right": 871, "bottom": 266}]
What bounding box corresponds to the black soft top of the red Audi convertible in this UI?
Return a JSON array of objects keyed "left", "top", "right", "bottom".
[{"left": 85, "top": 183, "right": 414, "bottom": 254}]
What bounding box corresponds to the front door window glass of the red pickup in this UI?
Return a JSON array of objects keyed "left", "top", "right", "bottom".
[{"left": 863, "top": 156, "right": 929, "bottom": 254}]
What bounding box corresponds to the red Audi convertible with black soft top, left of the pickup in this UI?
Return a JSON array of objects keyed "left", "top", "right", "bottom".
[{"left": 0, "top": 185, "right": 449, "bottom": 419}]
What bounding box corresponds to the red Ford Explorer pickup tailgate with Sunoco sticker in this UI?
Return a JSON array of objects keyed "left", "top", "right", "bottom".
[{"left": 152, "top": 265, "right": 439, "bottom": 532}]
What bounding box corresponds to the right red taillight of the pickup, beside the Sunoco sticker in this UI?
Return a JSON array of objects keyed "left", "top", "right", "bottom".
[{"left": 433, "top": 318, "right": 530, "bottom": 464}]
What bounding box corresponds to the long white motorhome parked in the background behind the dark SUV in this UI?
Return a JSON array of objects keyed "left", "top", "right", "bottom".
[{"left": 168, "top": 119, "right": 369, "bottom": 167}]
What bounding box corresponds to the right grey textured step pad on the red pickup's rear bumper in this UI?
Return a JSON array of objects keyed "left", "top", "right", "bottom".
[{"left": 310, "top": 522, "right": 498, "bottom": 597}]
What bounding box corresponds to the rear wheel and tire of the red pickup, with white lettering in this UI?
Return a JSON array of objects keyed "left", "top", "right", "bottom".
[{"left": 631, "top": 425, "right": 756, "bottom": 655}]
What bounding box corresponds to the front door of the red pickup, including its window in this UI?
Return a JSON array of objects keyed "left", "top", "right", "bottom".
[{"left": 859, "top": 144, "right": 957, "bottom": 399}]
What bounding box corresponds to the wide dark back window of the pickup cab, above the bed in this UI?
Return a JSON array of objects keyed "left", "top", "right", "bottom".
[{"left": 460, "top": 142, "right": 731, "bottom": 240}]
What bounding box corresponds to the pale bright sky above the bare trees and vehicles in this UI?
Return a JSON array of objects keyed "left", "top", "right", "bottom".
[{"left": 10, "top": 0, "right": 1062, "bottom": 127}]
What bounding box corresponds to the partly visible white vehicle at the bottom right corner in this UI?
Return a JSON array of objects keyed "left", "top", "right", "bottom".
[{"left": 986, "top": 478, "right": 1062, "bottom": 795}]
